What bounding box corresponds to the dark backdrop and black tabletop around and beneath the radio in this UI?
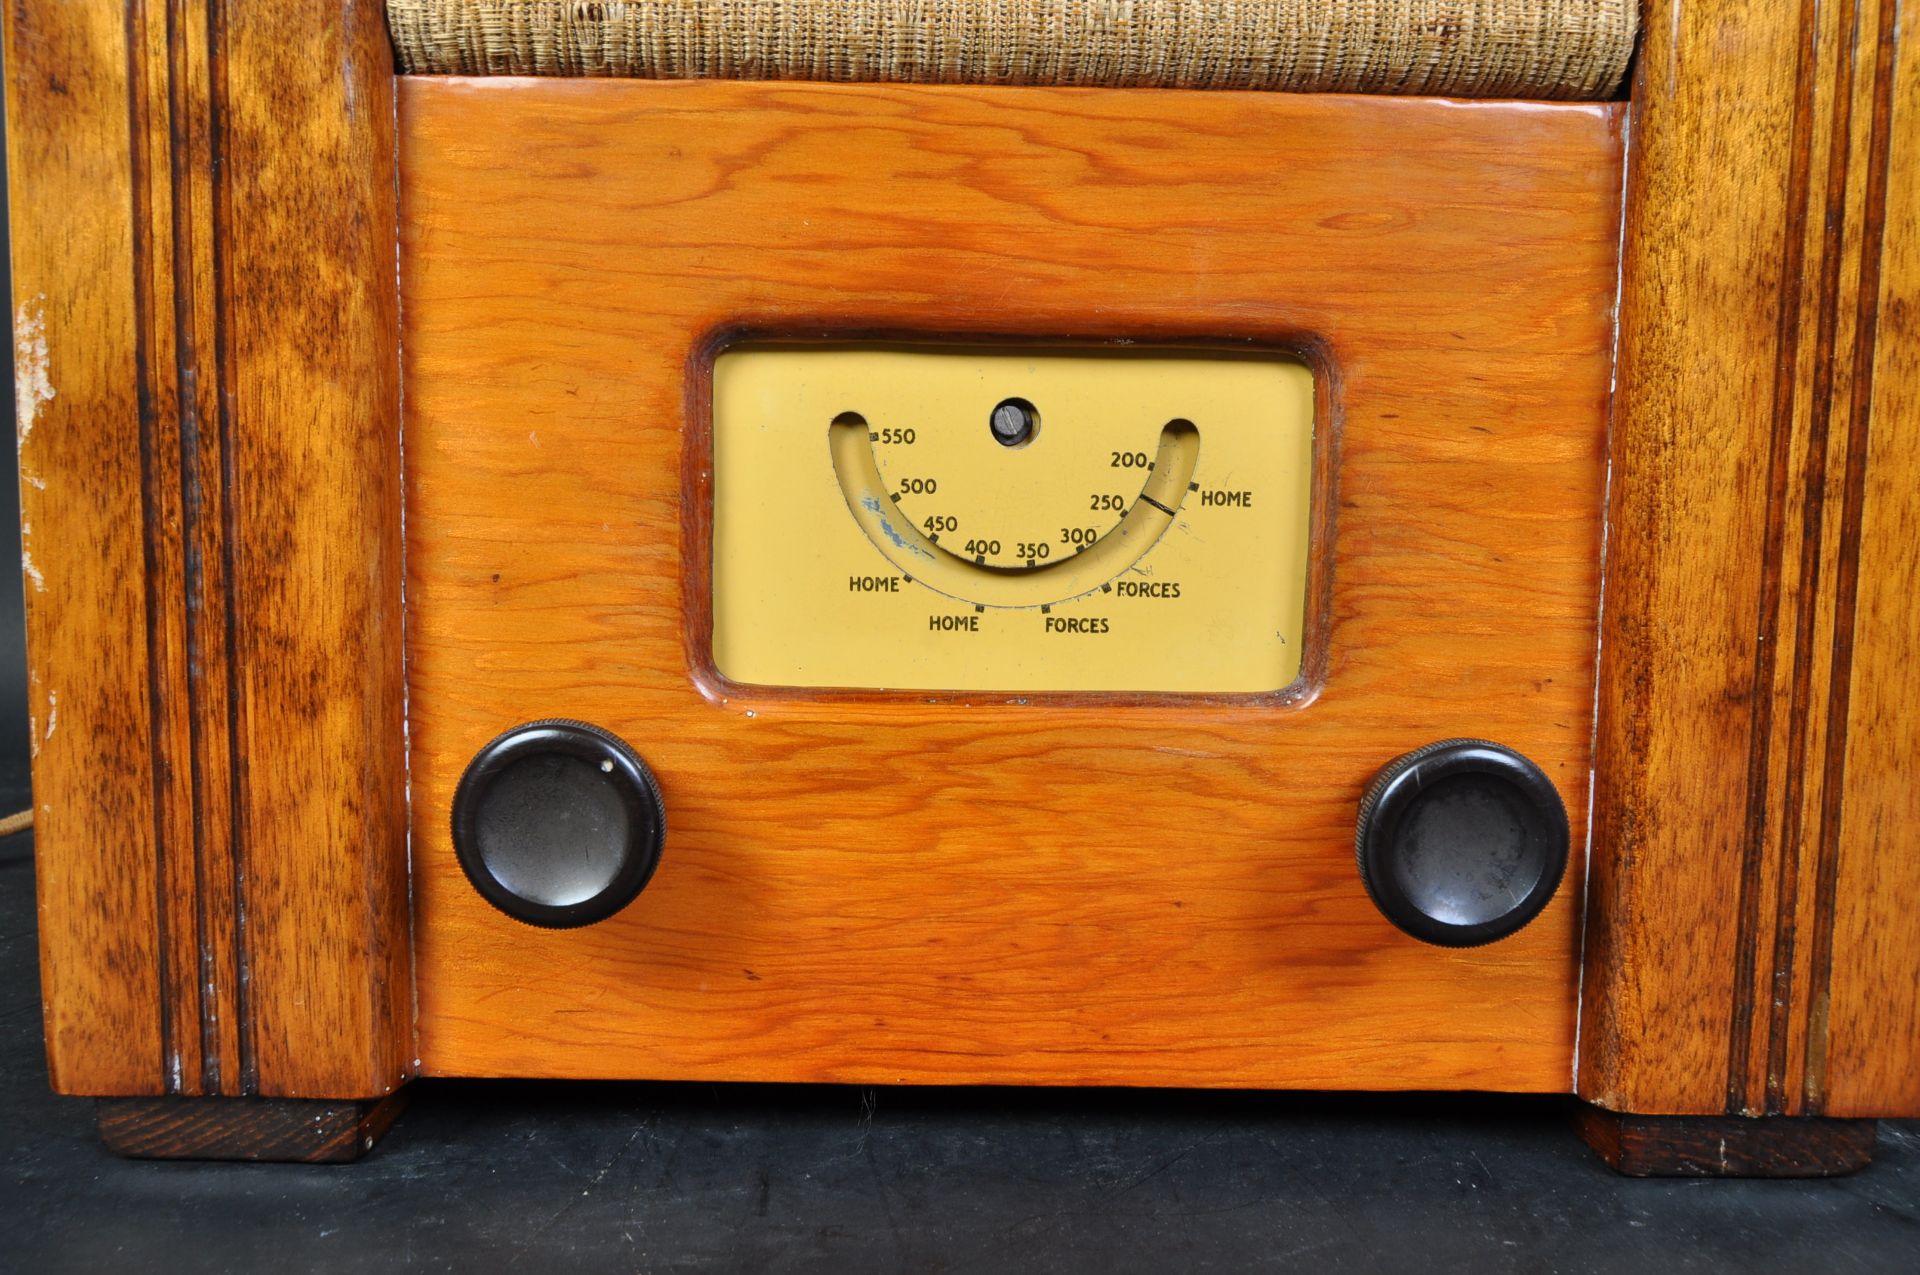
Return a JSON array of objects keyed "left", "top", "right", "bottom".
[{"left": 0, "top": 109, "right": 1920, "bottom": 1275}]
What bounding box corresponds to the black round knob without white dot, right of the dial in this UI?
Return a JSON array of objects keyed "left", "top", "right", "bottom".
[{"left": 1354, "top": 739, "right": 1569, "bottom": 947}]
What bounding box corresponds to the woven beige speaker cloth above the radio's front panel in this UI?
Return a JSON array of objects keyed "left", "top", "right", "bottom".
[{"left": 388, "top": 0, "right": 1638, "bottom": 100}]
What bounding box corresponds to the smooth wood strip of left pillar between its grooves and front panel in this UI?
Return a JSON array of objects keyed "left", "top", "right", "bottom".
[{"left": 219, "top": 0, "right": 415, "bottom": 1098}]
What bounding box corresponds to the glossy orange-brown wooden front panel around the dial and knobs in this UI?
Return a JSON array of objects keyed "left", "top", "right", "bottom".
[{"left": 399, "top": 79, "right": 1620, "bottom": 1091}]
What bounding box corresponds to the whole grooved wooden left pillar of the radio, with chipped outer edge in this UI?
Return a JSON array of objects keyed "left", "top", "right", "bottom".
[{"left": 6, "top": 0, "right": 413, "bottom": 1096}]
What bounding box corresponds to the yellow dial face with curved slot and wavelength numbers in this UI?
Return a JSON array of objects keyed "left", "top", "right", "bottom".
[{"left": 712, "top": 344, "right": 1313, "bottom": 693}]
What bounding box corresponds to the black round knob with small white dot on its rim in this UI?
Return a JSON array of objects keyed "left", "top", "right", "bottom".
[{"left": 453, "top": 720, "right": 666, "bottom": 929}]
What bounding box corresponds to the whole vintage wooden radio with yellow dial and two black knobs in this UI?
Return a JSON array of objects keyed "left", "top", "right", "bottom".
[{"left": 6, "top": 0, "right": 1920, "bottom": 1173}]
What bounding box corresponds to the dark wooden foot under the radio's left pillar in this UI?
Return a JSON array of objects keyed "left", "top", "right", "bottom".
[{"left": 94, "top": 1091, "right": 405, "bottom": 1164}]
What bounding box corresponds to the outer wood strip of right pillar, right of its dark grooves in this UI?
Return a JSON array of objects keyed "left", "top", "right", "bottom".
[{"left": 1811, "top": 2, "right": 1920, "bottom": 1116}]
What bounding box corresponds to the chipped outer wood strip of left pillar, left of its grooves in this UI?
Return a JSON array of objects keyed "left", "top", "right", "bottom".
[{"left": 0, "top": 4, "right": 169, "bottom": 1093}]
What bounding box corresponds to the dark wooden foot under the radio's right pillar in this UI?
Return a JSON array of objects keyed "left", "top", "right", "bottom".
[{"left": 1576, "top": 1102, "right": 1876, "bottom": 1177}]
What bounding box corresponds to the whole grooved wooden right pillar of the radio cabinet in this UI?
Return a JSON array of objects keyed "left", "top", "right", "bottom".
[{"left": 1580, "top": 0, "right": 1920, "bottom": 1114}]
